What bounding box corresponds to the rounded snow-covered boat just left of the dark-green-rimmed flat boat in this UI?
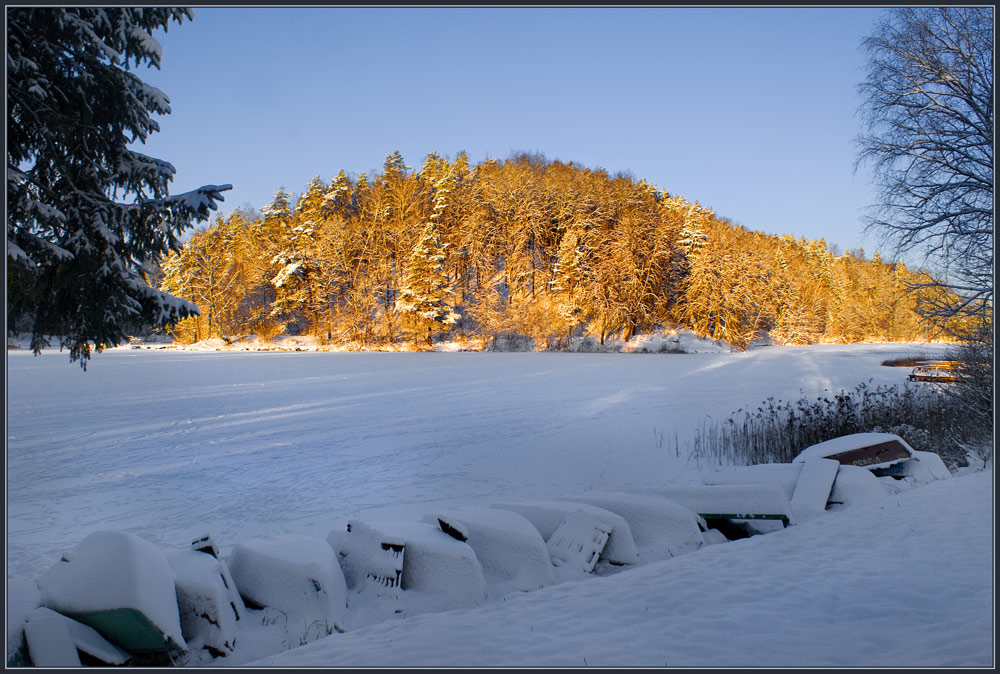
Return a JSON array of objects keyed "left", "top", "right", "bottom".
[{"left": 558, "top": 492, "right": 705, "bottom": 562}]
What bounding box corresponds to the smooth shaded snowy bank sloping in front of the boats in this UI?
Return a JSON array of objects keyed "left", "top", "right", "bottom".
[{"left": 251, "top": 471, "right": 996, "bottom": 670}]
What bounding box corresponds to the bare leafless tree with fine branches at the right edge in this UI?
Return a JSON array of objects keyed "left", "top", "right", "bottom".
[{"left": 858, "top": 7, "right": 993, "bottom": 321}]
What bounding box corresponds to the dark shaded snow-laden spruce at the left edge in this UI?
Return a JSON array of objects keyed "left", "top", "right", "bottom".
[{"left": 7, "top": 7, "right": 232, "bottom": 368}]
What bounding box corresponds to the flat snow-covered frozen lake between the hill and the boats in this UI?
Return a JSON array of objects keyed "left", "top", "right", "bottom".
[{"left": 7, "top": 344, "right": 934, "bottom": 578}]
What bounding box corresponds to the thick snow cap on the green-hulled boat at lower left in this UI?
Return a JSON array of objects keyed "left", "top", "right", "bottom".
[{"left": 38, "top": 531, "right": 187, "bottom": 649}]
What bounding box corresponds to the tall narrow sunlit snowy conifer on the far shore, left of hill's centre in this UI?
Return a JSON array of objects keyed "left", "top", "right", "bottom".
[{"left": 396, "top": 174, "right": 459, "bottom": 347}]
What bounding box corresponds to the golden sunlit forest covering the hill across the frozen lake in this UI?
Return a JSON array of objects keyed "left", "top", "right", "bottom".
[{"left": 155, "top": 152, "right": 968, "bottom": 348}]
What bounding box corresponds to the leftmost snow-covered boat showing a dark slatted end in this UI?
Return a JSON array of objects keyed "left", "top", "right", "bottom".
[{"left": 331, "top": 520, "right": 486, "bottom": 606}]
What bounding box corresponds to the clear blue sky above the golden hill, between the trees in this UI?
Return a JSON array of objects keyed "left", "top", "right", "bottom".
[{"left": 140, "top": 7, "right": 881, "bottom": 253}]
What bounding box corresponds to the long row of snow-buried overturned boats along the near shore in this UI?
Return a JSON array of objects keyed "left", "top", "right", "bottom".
[{"left": 7, "top": 437, "right": 950, "bottom": 667}]
